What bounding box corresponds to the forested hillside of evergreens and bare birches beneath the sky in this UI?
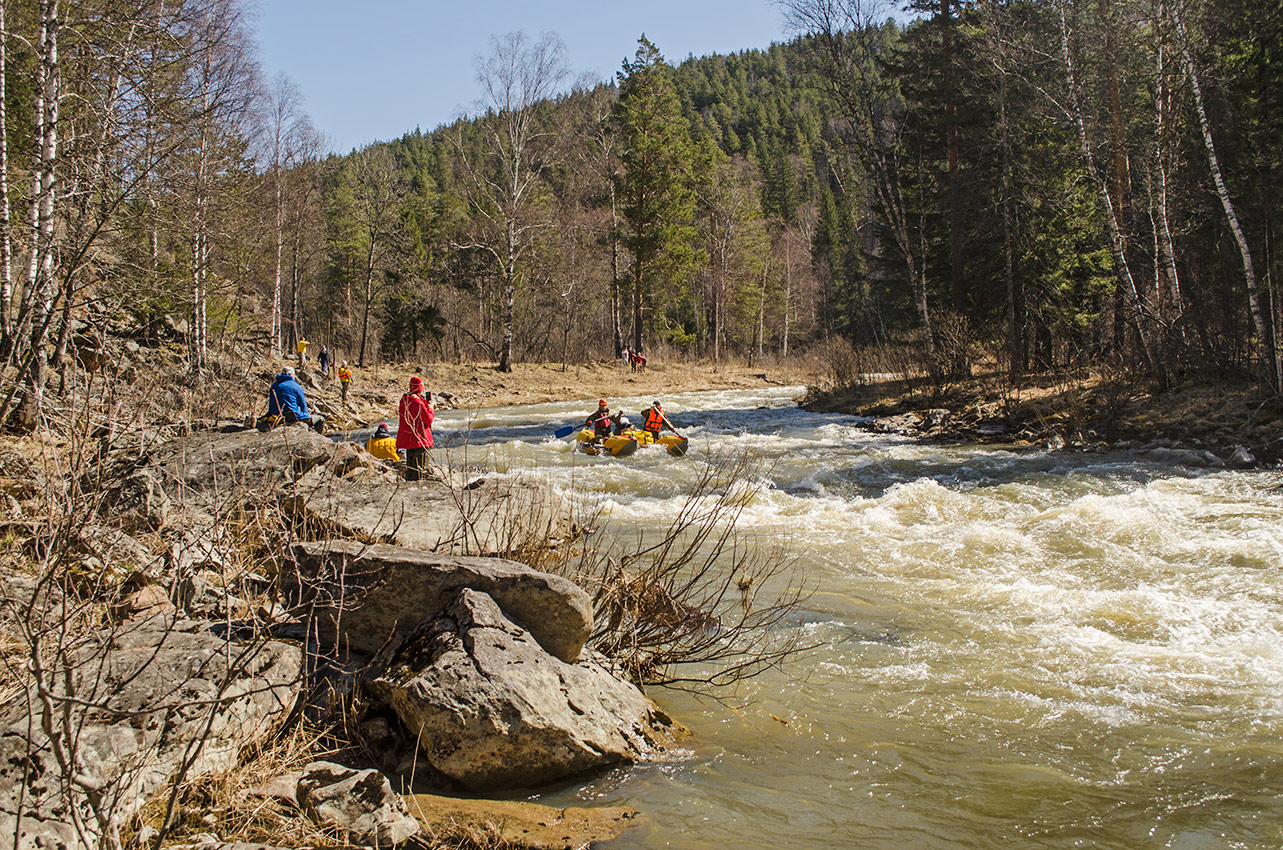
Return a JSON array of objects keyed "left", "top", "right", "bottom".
[{"left": 0, "top": 0, "right": 1283, "bottom": 422}]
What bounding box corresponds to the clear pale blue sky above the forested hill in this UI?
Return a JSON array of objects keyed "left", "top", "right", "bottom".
[{"left": 249, "top": 0, "right": 790, "bottom": 153}]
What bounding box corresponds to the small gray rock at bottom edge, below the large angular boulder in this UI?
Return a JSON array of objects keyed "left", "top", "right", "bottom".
[{"left": 295, "top": 762, "right": 421, "bottom": 847}]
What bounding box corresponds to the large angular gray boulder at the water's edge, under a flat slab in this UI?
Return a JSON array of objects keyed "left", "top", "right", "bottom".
[{"left": 368, "top": 590, "right": 668, "bottom": 790}]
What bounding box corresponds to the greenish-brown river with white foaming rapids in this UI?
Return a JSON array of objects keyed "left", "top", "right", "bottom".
[{"left": 423, "top": 387, "right": 1283, "bottom": 850}]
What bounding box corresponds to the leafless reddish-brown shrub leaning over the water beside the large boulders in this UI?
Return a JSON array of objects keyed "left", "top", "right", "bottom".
[{"left": 551, "top": 454, "right": 810, "bottom": 688}]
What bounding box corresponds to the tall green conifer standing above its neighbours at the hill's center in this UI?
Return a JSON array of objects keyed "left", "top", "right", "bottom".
[{"left": 613, "top": 36, "right": 695, "bottom": 349}]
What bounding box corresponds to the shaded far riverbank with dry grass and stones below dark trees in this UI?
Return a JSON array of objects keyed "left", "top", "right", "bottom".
[{"left": 803, "top": 376, "right": 1283, "bottom": 468}]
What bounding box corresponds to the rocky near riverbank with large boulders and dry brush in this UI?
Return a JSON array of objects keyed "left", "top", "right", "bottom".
[{"left": 0, "top": 422, "right": 676, "bottom": 847}]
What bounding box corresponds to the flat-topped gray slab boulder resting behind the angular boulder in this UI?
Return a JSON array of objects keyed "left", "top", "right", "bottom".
[{"left": 291, "top": 541, "right": 593, "bottom": 662}]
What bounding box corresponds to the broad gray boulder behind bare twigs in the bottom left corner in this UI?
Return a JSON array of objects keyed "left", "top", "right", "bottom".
[{"left": 0, "top": 617, "right": 303, "bottom": 850}]
